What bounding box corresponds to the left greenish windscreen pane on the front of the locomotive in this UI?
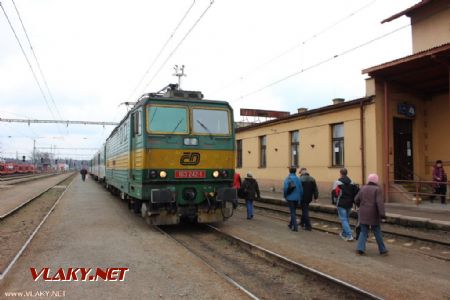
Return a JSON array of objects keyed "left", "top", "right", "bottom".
[{"left": 147, "top": 105, "right": 188, "bottom": 133}]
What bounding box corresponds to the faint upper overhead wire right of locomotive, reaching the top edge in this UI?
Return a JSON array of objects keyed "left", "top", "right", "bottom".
[{"left": 214, "top": 0, "right": 377, "bottom": 93}]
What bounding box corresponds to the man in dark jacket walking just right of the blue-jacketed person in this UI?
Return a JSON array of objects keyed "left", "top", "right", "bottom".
[{"left": 300, "top": 168, "right": 319, "bottom": 231}]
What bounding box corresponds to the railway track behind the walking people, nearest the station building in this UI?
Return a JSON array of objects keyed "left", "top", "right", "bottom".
[{"left": 246, "top": 202, "right": 450, "bottom": 261}]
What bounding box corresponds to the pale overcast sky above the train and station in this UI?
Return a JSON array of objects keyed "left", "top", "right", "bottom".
[{"left": 0, "top": 0, "right": 419, "bottom": 158}]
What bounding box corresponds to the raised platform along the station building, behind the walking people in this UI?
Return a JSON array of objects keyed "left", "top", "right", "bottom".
[{"left": 261, "top": 191, "right": 450, "bottom": 231}]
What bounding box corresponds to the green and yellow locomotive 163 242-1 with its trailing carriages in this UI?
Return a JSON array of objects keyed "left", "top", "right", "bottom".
[{"left": 89, "top": 84, "right": 237, "bottom": 225}]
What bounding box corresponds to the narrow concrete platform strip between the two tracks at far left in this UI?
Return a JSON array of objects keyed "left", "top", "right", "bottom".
[{"left": 0, "top": 173, "right": 72, "bottom": 217}]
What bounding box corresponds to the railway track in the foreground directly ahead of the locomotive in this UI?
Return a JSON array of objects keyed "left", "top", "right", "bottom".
[{"left": 157, "top": 225, "right": 381, "bottom": 299}]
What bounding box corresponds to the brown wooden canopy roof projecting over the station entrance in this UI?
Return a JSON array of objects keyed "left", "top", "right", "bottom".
[{"left": 362, "top": 43, "right": 450, "bottom": 95}]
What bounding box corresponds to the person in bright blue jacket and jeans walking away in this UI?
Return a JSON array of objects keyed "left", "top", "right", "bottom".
[{"left": 283, "top": 167, "right": 303, "bottom": 231}]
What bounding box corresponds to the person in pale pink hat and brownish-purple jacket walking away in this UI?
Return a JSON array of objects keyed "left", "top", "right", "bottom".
[{"left": 355, "top": 174, "right": 388, "bottom": 255}]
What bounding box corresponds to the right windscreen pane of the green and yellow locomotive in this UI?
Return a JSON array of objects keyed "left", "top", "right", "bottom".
[{"left": 192, "top": 108, "right": 230, "bottom": 134}]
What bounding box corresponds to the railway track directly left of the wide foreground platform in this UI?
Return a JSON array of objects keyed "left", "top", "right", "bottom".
[{"left": 0, "top": 174, "right": 76, "bottom": 280}]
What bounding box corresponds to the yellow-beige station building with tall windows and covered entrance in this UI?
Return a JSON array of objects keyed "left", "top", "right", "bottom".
[{"left": 236, "top": 0, "right": 450, "bottom": 201}]
